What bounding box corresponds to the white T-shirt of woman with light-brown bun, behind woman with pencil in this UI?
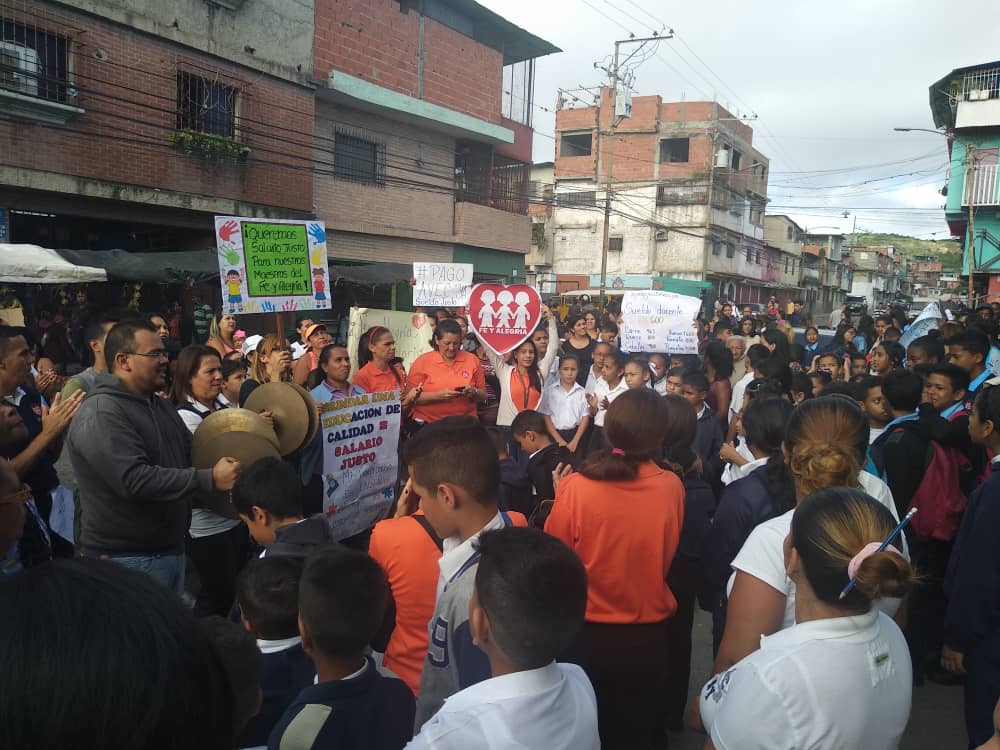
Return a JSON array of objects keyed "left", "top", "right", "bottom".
[{"left": 726, "top": 471, "right": 909, "bottom": 630}]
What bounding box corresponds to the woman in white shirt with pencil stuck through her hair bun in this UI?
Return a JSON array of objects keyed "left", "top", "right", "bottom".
[{"left": 701, "top": 487, "right": 914, "bottom": 750}]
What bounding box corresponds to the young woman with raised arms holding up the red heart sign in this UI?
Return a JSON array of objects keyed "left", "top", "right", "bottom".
[{"left": 486, "top": 305, "right": 559, "bottom": 428}]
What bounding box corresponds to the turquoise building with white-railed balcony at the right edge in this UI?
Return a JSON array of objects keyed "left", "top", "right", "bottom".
[{"left": 930, "top": 61, "right": 1000, "bottom": 304}]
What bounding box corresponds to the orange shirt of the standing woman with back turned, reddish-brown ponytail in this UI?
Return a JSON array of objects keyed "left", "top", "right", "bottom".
[{"left": 545, "top": 461, "right": 684, "bottom": 625}]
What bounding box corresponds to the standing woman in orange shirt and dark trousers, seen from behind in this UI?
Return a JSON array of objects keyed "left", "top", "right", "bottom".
[{"left": 545, "top": 388, "right": 684, "bottom": 748}]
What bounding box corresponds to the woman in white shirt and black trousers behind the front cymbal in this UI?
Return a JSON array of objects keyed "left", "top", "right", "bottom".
[{"left": 170, "top": 346, "right": 250, "bottom": 617}]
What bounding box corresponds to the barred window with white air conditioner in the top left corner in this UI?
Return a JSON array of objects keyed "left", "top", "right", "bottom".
[{"left": 0, "top": 18, "right": 69, "bottom": 102}]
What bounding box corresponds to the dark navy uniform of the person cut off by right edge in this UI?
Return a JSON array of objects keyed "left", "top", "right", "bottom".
[{"left": 944, "top": 457, "right": 1000, "bottom": 747}]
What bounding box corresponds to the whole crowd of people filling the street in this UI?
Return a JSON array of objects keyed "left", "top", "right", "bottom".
[{"left": 0, "top": 290, "right": 1000, "bottom": 750}]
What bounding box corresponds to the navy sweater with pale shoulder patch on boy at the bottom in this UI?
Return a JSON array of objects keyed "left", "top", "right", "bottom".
[{"left": 267, "top": 657, "right": 413, "bottom": 750}]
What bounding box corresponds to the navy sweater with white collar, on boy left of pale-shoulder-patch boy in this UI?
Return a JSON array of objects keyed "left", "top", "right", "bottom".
[{"left": 237, "top": 636, "right": 316, "bottom": 747}]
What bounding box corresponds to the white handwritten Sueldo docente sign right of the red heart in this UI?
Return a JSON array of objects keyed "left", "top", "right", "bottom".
[{"left": 620, "top": 291, "right": 701, "bottom": 354}]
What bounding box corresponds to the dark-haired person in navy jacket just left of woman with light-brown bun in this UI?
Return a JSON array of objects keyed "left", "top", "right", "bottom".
[{"left": 700, "top": 396, "right": 795, "bottom": 651}]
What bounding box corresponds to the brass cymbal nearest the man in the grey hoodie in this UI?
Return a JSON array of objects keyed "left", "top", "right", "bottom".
[{"left": 191, "top": 409, "right": 280, "bottom": 469}]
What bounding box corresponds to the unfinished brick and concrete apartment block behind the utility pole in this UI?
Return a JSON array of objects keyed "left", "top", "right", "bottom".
[{"left": 551, "top": 94, "right": 775, "bottom": 302}]
